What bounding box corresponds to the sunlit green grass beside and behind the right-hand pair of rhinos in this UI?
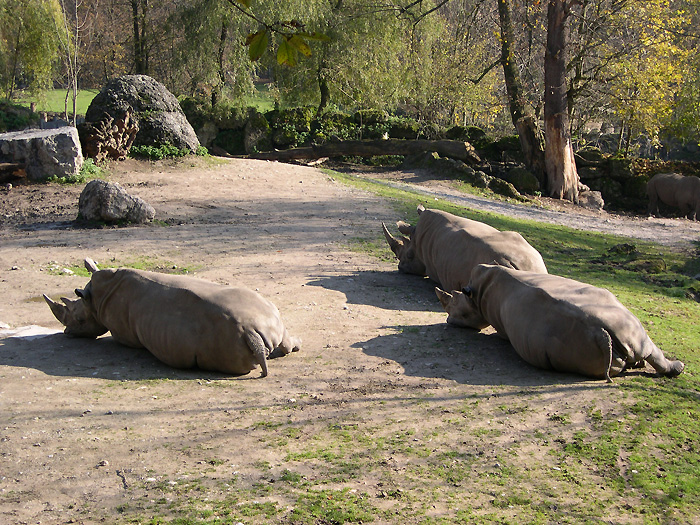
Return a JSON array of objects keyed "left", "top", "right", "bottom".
[{"left": 330, "top": 173, "right": 700, "bottom": 523}]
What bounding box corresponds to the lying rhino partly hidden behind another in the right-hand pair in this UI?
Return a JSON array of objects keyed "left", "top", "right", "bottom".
[{"left": 382, "top": 205, "right": 547, "bottom": 290}]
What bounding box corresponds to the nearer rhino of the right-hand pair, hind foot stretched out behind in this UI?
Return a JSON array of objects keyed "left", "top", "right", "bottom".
[{"left": 435, "top": 264, "right": 684, "bottom": 381}]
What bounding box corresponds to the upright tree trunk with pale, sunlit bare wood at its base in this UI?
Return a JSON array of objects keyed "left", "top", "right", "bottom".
[{"left": 544, "top": 0, "right": 579, "bottom": 203}]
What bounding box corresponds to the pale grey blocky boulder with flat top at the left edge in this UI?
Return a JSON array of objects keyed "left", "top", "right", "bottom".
[{"left": 0, "top": 126, "right": 83, "bottom": 181}]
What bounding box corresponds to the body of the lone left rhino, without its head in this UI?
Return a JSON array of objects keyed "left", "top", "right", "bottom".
[{"left": 93, "top": 270, "right": 284, "bottom": 373}]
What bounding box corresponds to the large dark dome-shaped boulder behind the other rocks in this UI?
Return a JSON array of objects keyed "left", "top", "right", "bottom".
[{"left": 85, "top": 75, "right": 199, "bottom": 152}]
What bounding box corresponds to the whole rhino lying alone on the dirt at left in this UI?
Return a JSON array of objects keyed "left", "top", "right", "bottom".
[{"left": 44, "top": 259, "right": 300, "bottom": 377}]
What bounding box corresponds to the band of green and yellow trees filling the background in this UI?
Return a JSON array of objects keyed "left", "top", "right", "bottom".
[{"left": 0, "top": 0, "right": 700, "bottom": 188}]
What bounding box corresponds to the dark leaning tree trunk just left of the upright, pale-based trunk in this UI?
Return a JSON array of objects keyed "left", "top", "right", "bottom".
[{"left": 497, "top": 0, "right": 547, "bottom": 188}]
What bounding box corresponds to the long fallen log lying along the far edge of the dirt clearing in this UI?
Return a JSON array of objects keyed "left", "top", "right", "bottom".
[{"left": 249, "top": 139, "right": 481, "bottom": 164}]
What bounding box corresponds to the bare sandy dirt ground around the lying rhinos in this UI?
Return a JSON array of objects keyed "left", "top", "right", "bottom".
[{"left": 0, "top": 159, "right": 700, "bottom": 523}]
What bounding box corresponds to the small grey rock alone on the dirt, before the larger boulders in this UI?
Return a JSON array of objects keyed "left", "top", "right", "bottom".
[{"left": 78, "top": 179, "right": 156, "bottom": 224}]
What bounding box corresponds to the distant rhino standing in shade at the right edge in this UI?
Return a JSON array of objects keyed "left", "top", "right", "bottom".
[{"left": 647, "top": 173, "right": 700, "bottom": 220}]
